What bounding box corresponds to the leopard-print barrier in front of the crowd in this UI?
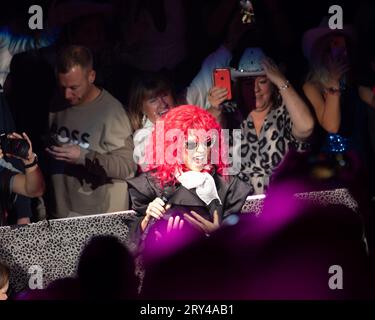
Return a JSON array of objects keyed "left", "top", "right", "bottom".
[{"left": 0, "top": 189, "right": 358, "bottom": 292}]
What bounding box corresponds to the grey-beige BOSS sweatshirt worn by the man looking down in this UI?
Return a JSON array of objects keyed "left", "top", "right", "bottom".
[{"left": 49, "top": 89, "right": 136, "bottom": 218}]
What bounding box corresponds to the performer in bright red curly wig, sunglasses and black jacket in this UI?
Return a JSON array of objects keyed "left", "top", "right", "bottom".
[{"left": 128, "top": 105, "right": 251, "bottom": 242}]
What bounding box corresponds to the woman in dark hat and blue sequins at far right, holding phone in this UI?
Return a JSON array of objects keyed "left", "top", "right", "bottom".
[{"left": 302, "top": 23, "right": 365, "bottom": 156}]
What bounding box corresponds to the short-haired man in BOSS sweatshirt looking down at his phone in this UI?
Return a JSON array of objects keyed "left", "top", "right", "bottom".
[{"left": 46, "top": 46, "right": 136, "bottom": 218}]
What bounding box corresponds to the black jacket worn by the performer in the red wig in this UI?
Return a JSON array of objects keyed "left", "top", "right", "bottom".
[{"left": 127, "top": 172, "right": 252, "bottom": 244}]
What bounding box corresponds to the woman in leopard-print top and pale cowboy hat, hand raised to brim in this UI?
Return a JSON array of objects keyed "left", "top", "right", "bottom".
[{"left": 208, "top": 48, "right": 314, "bottom": 194}]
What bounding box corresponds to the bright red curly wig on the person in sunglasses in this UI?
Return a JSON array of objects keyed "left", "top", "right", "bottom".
[{"left": 146, "top": 105, "right": 227, "bottom": 186}]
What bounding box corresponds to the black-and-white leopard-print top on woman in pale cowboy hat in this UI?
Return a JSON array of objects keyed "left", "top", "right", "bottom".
[{"left": 238, "top": 105, "right": 308, "bottom": 194}]
